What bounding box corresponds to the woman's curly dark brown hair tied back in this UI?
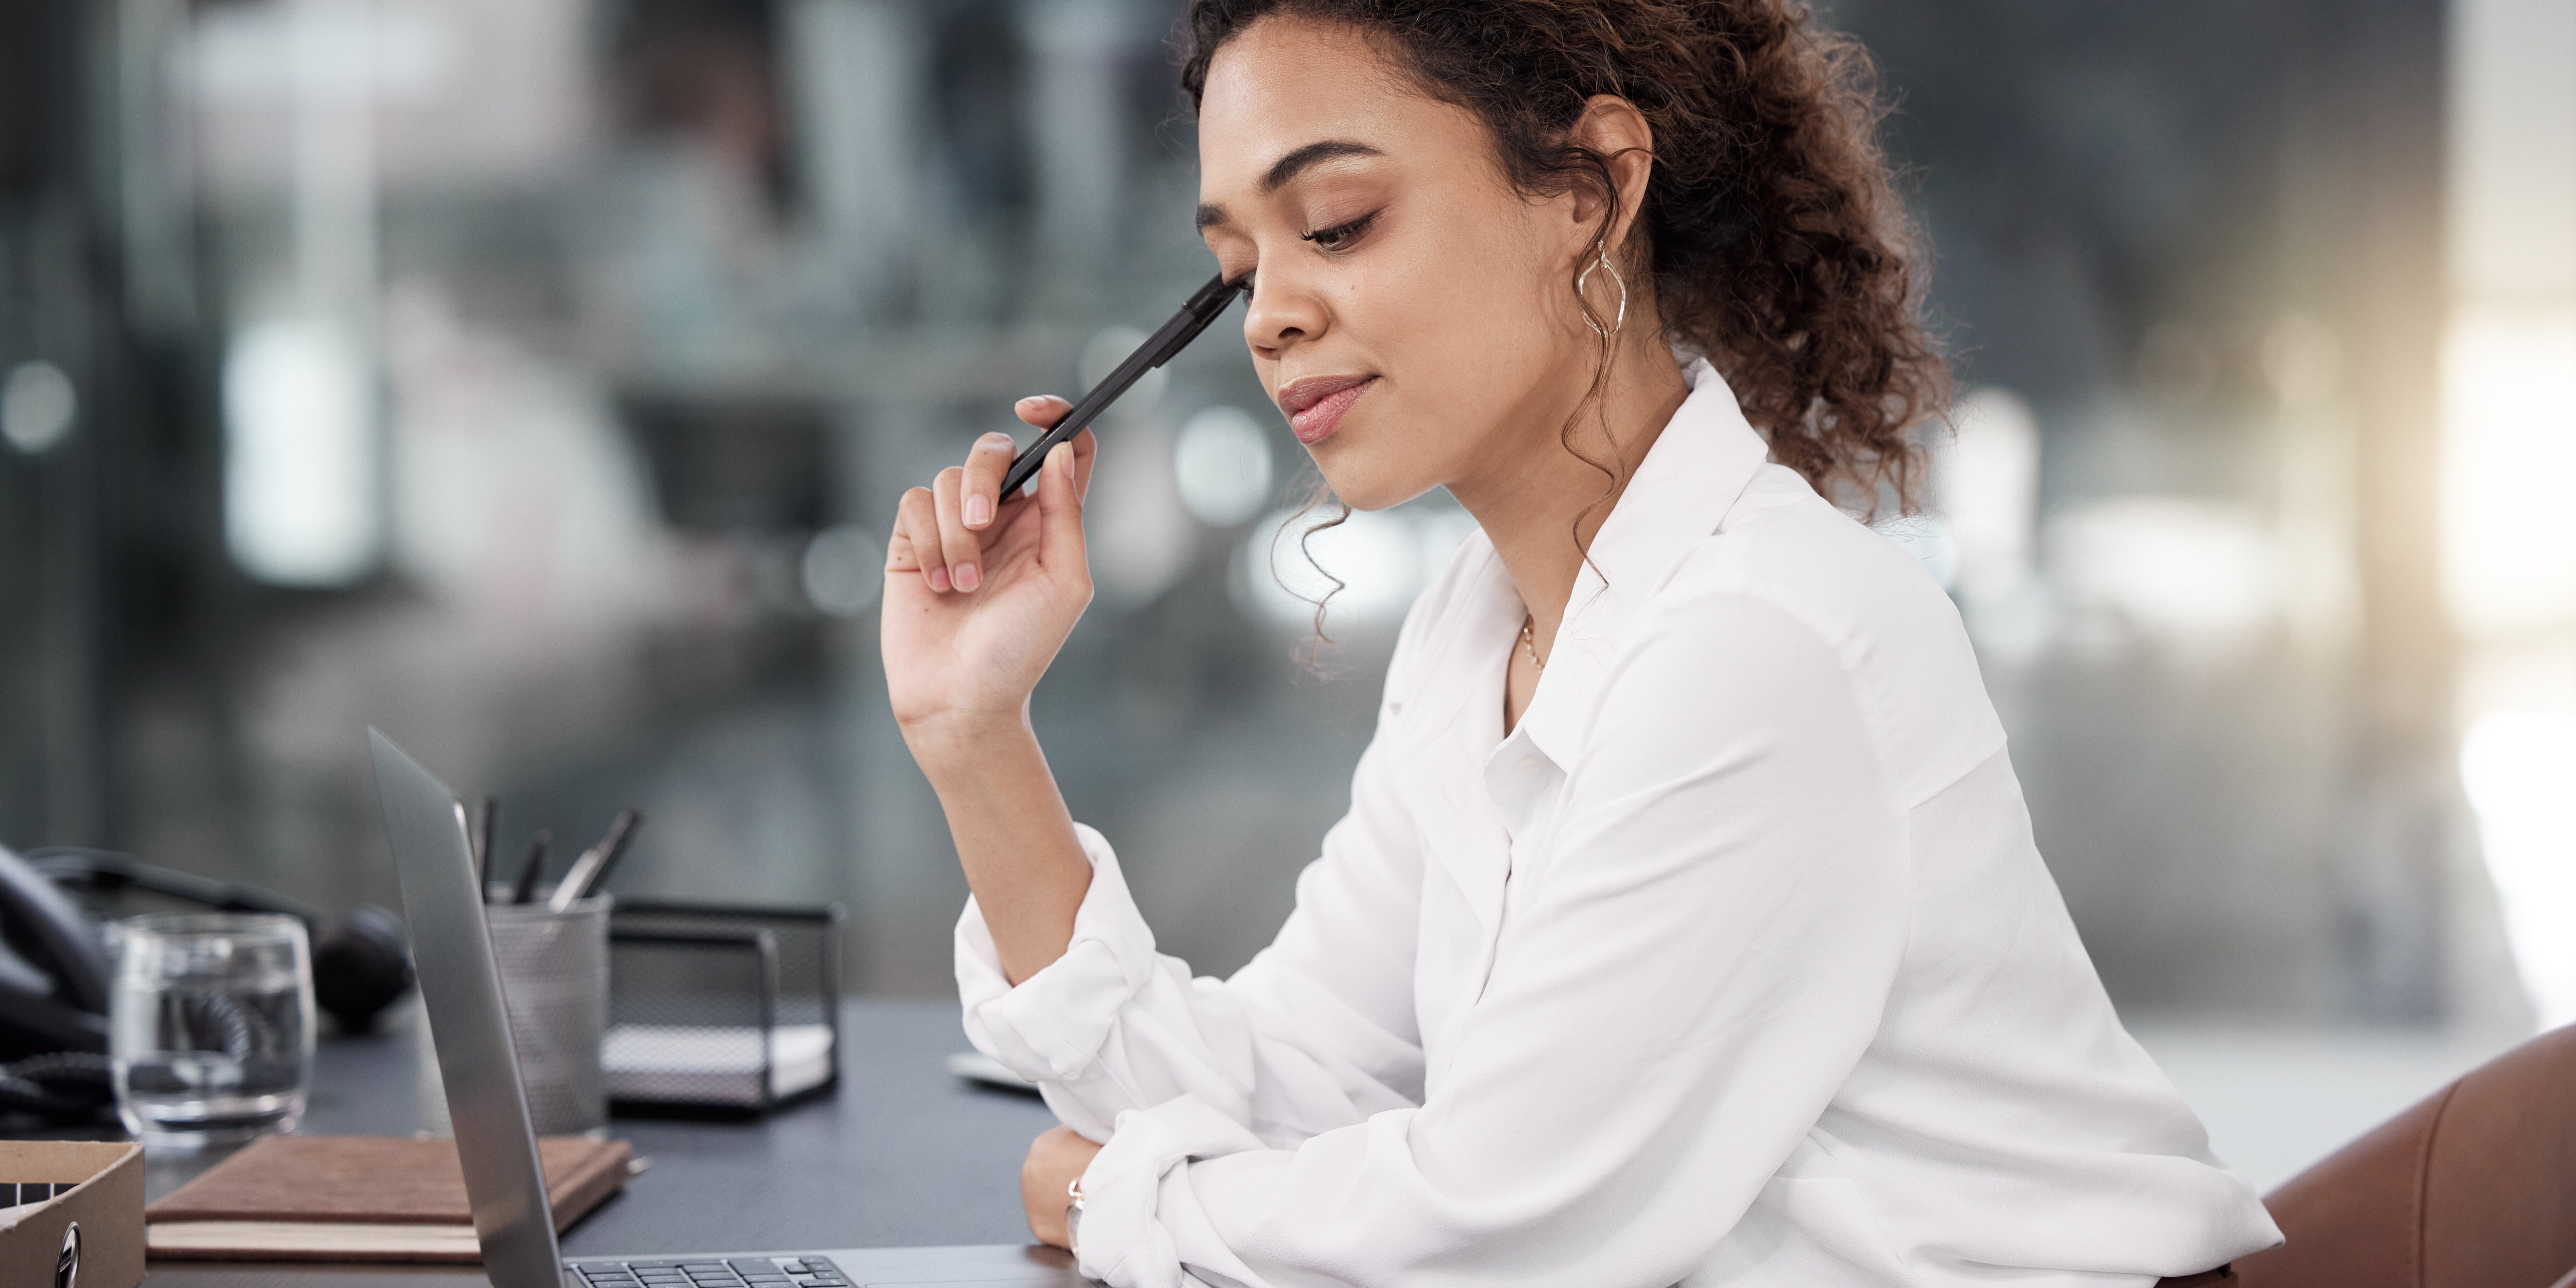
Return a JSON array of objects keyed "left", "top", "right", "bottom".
[{"left": 1180, "top": 0, "right": 1950, "bottom": 512}]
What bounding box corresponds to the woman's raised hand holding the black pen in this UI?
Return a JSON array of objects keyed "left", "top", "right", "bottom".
[{"left": 881, "top": 397, "right": 1095, "bottom": 755}]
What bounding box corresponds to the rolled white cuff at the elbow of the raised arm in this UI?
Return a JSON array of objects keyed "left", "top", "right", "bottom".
[{"left": 956, "top": 824, "right": 1154, "bottom": 1082}]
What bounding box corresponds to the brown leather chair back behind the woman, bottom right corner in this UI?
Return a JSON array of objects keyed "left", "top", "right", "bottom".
[{"left": 2236, "top": 1025, "right": 2576, "bottom": 1288}]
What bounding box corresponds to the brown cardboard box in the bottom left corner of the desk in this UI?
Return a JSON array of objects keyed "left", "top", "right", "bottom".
[{"left": 0, "top": 1141, "right": 144, "bottom": 1288}]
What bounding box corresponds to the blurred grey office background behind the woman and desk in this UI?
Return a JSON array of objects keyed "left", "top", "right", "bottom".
[{"left": 0, "top": 0, "right": 2576, "bottom": 1180}]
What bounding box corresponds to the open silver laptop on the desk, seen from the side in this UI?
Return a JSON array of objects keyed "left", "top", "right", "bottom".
[{"left": 366, "top": 729, "right": 1085, "bottom": 1288}]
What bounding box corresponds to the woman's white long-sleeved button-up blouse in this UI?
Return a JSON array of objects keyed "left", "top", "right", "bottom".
[{"left": 956, "top": 363, "right": 2280, "bottom": 1288}]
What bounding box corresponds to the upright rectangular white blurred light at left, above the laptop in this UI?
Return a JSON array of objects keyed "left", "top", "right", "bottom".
[{"left": 224, "top": 317, "right": 384, "bottom": 587}]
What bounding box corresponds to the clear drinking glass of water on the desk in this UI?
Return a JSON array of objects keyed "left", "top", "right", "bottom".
[{"left": 108, "top": 912, "right": 314, "bottom": 1146}]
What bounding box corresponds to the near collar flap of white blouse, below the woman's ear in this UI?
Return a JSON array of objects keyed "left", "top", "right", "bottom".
[{"left": 1494, "top": 358, "right": 1770, "bottom": 768}]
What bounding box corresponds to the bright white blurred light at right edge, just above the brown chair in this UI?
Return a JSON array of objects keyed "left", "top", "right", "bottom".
[{"left": 2460, "top": 711, "right": 2576, "bottom": 1028}]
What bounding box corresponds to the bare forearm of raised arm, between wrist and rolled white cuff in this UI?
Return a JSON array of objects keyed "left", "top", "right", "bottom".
[{"left": 904, "top": 721, "right": 1092, "bottom": 984}]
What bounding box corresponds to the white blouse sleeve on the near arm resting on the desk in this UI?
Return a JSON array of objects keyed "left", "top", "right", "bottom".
[{"left": 1056, "top": 595, "right": 1909, "bottom": 1288}]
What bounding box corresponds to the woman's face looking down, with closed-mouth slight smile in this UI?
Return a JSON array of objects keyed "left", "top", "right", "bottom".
[{"left": 1198, "top": 18, "right": 1600, "bottom": 510}]
